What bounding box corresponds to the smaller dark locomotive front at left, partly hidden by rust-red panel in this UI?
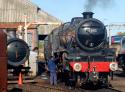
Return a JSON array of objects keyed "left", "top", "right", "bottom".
[{"left": 6, "top": 29, "right": 30, "bottom": 76}]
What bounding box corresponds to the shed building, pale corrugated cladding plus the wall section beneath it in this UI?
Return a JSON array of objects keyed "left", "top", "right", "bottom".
[{"left": 0, "top": 0, "right": 61, "bottom": 50}]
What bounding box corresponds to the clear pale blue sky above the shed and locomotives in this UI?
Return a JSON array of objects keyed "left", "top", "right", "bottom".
[{"left": 32, "top": 0, "right": 125, "bottom": 35}]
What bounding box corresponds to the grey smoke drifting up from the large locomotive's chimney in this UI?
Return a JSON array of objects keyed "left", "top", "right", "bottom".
[{"left": 85, "top": 0, "right": 113, "bottom": 11}]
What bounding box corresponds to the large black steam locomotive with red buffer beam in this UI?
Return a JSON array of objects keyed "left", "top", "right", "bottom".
[{"left": 44, "top": 12, "right": 118, "bottom": 85}]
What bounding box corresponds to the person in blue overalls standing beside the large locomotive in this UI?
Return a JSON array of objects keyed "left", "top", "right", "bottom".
[{"left": 48, "top": 56, "right": 57, "bottom": 85}]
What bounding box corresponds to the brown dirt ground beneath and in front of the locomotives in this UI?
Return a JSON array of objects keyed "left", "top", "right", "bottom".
[{"left": 8, "top": 72, "right": 125, "bottom": 92}]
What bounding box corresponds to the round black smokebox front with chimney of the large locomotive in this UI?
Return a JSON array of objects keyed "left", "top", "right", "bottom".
[{"left": 76, "top": 12, "right": 107, "bottom": 52}]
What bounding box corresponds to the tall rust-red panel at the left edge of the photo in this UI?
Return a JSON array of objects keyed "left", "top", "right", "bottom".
[{"left": 0, "top": 30, "right": 7, "bottom": 92}]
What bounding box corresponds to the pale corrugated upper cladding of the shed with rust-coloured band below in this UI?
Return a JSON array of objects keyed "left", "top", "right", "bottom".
[{"left": 0, "top": 0, "right": 61, "bottom": 34}]
